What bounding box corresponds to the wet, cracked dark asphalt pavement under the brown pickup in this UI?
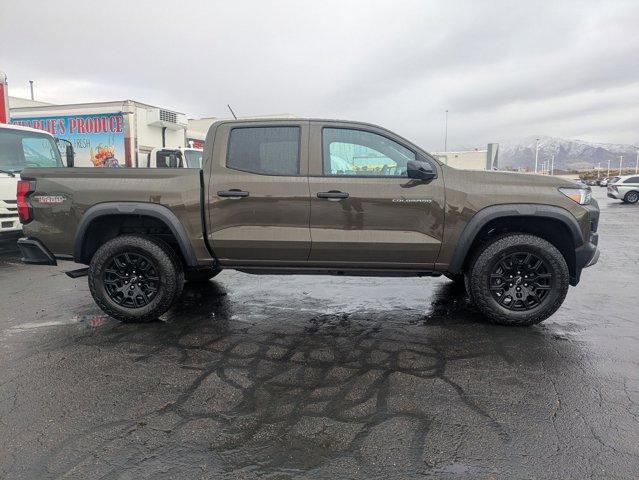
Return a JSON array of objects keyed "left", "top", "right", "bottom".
[{"left": 0, "top": 187, "right": 639, "bottom": 479}]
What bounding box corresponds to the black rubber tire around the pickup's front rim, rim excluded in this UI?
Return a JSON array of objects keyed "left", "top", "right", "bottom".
[{"left": 468, "top": 233, "right": 570, "bottom": 326}]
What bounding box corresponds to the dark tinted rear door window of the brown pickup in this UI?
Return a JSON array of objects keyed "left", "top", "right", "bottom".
[{"left": 226, "top": 127, "right": 300, "bottom": 175}]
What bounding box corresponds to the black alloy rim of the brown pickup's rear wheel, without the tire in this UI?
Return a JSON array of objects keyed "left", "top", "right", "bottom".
[{"left": 102, "top": 252, "right": 160, "bottom": 308}]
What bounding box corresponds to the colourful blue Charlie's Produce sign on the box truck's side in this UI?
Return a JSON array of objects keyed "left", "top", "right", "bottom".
[{"left": 11, "top": 113, "right": 125, "bottom": 167}]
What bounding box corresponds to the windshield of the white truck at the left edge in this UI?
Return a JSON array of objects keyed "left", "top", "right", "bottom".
[{"left": 0, "top": 129, "right": 63, "bottom": 172}]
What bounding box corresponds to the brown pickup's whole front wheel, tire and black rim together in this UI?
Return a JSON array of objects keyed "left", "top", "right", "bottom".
[{"left": 468, "top": 234, "right": 570, "bottom": 326}]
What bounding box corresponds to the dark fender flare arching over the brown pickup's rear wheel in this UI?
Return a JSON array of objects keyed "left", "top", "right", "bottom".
[{"left": 73, "top": 202, "right": 198, "bottom": 267}]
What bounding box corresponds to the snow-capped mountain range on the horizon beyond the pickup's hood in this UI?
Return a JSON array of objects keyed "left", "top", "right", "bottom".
[{"left": 499, "top": 135, "right": 639, "bottom": 170}]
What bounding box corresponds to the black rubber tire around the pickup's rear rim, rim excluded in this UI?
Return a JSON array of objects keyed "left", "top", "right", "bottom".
[{"left": 88, "top": 235, "right": 184, "bottom": 323}]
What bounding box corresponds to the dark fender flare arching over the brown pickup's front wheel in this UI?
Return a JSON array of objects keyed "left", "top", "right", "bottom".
[{"left": 447, "top": 203, "right": 584, "bottom": 273}]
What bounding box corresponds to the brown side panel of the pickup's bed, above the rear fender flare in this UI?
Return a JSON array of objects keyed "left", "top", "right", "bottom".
[{"left": 21, "top": 168, "right": 211, "bottom": 262}]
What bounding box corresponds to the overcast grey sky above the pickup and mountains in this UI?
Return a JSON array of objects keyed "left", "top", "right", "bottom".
[{"left": 0, "top": 0, "right": 639, "bottom": 150}]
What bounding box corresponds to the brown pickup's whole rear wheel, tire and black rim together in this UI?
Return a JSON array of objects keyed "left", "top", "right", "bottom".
[{"left": 89, "top": 235, "right": 184, "bottom": 322}]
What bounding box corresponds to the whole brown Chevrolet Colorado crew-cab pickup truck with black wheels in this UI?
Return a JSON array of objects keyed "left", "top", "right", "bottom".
[{"left": 18, "top": 119, "right": 599, "bottom": 325}]
